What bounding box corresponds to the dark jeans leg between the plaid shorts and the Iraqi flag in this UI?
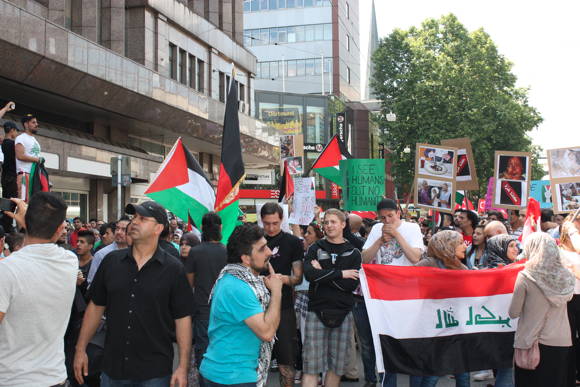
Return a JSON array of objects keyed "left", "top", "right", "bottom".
[{"left": 352, "top": 298, "right": 378, "bottom": 384}]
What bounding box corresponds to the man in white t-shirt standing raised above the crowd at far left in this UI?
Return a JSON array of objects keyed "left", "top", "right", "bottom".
[{"left": 14, "top": 114, "right": 44, "bottom": 200}]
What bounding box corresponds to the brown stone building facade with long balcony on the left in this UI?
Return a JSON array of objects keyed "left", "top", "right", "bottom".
[{"left": 0, "top": 0, "right": 279, "bottom": 220}]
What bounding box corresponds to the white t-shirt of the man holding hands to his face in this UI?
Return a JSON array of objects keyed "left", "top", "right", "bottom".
[{"left": 363, "top": 221, "right": 424, "bottom": 266}]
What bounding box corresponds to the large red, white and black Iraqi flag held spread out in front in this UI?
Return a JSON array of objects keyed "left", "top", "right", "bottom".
[{"left": 360, "top": 265, "right": 523, "bottom": 376}]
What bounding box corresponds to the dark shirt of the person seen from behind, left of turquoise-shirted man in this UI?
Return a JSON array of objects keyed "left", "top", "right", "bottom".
[{"left": 185, "top": 242, "right": 227, "bottom": 320}]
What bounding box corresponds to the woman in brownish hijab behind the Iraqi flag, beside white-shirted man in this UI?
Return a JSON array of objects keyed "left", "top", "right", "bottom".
[{"left": 410, "top": 230, "right": 470, "bottom": 387}]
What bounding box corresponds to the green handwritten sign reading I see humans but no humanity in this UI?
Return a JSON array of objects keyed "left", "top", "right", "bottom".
[{"left": 340, "top": 159, "right": 385, "bottom": 211}]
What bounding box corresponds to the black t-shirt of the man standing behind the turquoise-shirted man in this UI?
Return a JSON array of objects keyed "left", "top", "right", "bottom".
[{"left": 264, "top": 231, "right": 304, "bottom": 309}]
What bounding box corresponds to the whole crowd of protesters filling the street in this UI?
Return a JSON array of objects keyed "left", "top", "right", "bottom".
[{"left": 0, "top": 192, "right": 580, "bottom": 387}]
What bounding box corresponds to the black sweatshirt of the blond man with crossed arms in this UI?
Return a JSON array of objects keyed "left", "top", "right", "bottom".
[{"left": 304, "top": 239, "right": 361, "bottom": 311}]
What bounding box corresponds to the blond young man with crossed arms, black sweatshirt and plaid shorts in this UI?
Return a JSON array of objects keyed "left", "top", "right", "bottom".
[{"left": 302, "top": 208, "right": 361, "bottom": 387}]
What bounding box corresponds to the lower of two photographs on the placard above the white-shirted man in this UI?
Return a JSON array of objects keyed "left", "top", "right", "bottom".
[{"left": 415, "top": 177, "right": 455, "bottom": 212}]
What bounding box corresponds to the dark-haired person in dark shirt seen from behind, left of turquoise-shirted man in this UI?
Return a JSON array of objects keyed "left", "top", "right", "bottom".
[{"left": 185, "top": 212, "right": 227, "bottom": 372}]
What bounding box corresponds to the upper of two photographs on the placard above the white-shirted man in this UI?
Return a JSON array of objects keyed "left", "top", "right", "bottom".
[{"left": 415, "top": 144, "right": 457, "bottom": 179}]
